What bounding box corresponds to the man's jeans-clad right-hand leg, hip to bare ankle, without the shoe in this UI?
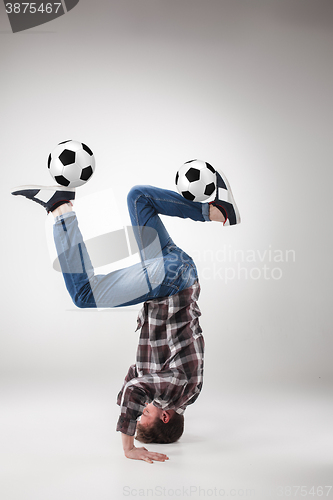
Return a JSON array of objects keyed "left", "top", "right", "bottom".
[{"left": 124, "top": 186, "right": 213, "bottom": 298}]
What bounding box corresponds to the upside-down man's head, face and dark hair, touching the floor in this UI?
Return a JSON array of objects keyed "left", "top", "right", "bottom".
[{"left": 136, "top": 403, "right": 184, "bottom": 443}]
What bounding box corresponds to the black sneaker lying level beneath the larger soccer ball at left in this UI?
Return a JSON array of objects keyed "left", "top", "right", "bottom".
[{"left": 12, "top": 186, "right": 75, "bottom": 213}]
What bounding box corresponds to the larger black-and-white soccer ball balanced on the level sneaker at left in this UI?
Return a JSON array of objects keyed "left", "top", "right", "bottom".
[{"left": 47, "top": 141, "right": 95, "bottom": 187}]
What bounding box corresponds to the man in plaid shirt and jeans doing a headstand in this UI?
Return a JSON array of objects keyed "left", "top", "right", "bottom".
[{"left": 12, "top": 168, "right": 240, "bottom": 463}]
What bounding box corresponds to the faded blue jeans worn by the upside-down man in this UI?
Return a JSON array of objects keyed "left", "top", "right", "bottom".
[{"left": 54, "top": 186, "right": 210, "bottom": 308}]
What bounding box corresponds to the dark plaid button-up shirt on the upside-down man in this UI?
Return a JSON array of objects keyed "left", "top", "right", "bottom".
[{"left": 117, "top": 282, "right": 204, "bottom": 436}]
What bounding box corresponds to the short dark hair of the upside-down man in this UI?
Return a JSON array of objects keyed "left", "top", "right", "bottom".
[{"left": 135, "top": 413, "right": 184, "bottom": 444}]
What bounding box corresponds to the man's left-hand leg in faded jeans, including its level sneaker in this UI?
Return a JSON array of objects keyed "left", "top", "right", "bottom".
[{"left": 12, "top": 185, "right": 157, "bottom": 307}]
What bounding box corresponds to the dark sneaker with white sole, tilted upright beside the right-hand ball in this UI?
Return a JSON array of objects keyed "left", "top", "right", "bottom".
[{"left": 210, "top": 169, "right": 241, "bottom": 226}]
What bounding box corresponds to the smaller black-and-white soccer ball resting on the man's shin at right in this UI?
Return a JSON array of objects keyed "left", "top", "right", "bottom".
[{"left": 176, "top": 160, "right": 216, "bottom": 201}]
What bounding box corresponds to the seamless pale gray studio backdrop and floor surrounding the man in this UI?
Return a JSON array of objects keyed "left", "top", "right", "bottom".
[{"left": 0, "top": 0, "right": 333, "bottom": 500}]
